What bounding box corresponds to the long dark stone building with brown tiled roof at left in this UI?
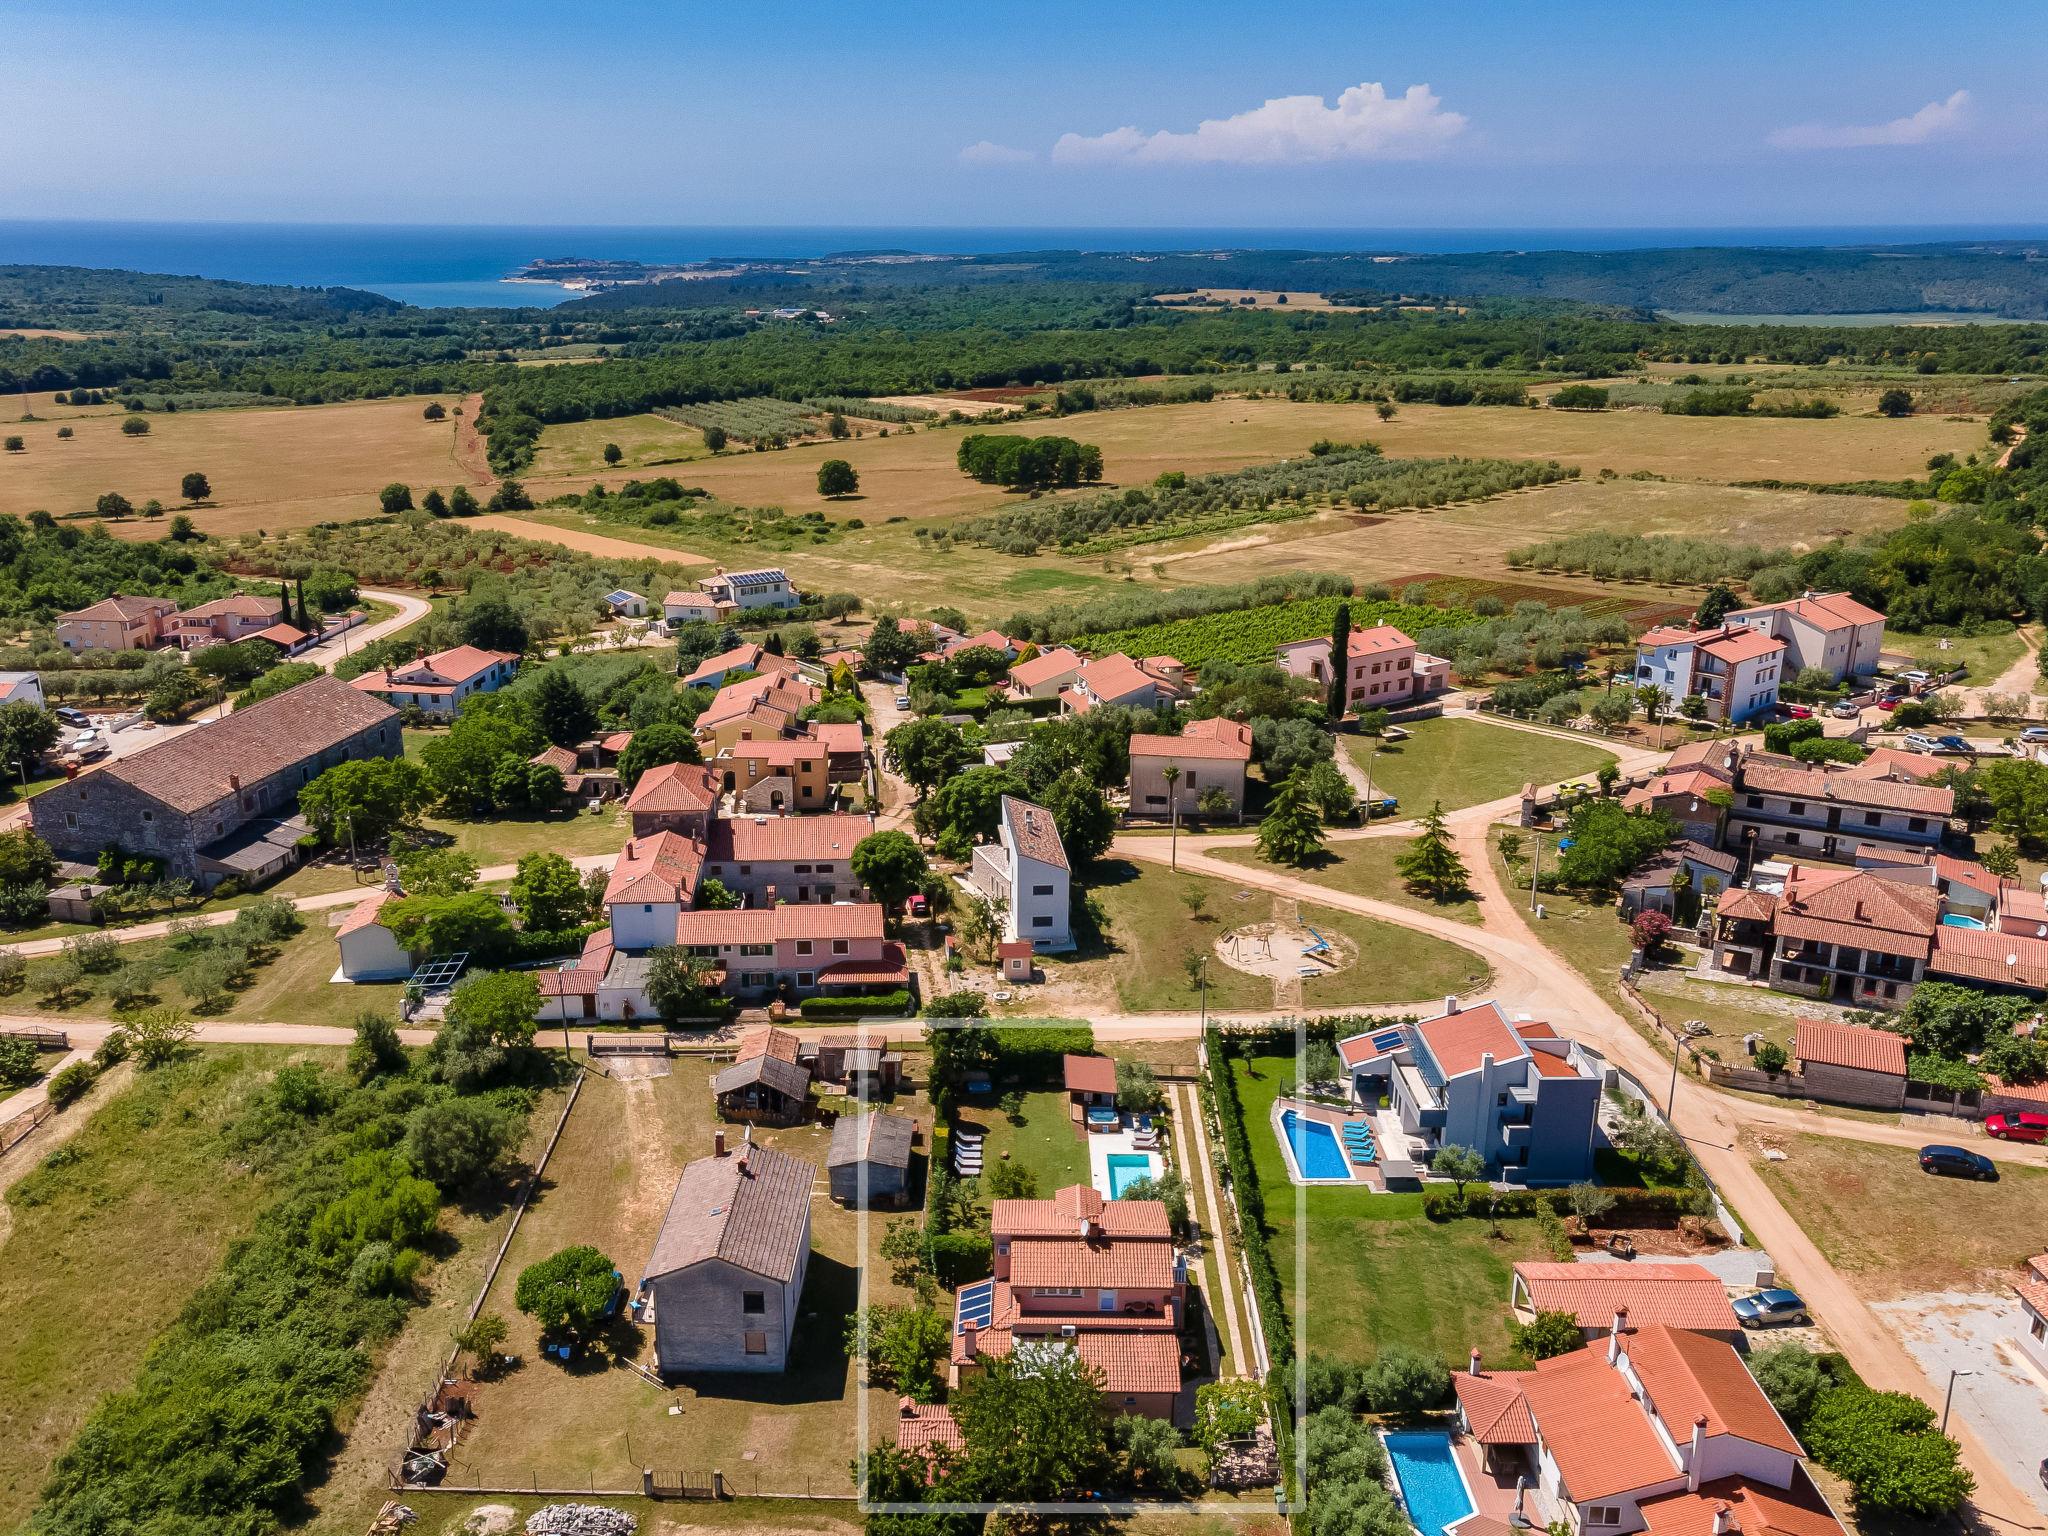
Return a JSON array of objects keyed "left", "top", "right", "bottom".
[{"left": 29, "top": 676, "right": 403, "bottom": 889}]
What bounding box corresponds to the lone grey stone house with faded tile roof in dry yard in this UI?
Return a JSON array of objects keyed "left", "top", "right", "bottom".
[{"left": 639, "top": 1138, "right": 811, "bottom": 1376}]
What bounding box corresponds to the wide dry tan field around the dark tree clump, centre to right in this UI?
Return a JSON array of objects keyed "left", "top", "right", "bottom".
[{"left": 528, "top": 399, "right": 1982, "bottom": 524}]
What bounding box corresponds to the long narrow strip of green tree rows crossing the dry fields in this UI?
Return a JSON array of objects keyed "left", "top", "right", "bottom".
[{"left": 930, "top": 442, "right": 1579, "bottom": 555}]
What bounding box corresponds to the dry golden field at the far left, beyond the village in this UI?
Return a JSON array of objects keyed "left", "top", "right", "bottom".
[{"left": 0, "top": 397, "right": 465, "bottom": 539}]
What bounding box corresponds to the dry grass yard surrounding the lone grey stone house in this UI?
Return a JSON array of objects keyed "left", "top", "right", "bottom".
[{"left": 455, "top": 1059, "right": 930, "bottom": 1493}]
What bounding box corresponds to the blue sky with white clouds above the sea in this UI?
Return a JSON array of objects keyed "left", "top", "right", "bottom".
[{"left": 0, "top": 0, "right": 2048, "bottom": 227}]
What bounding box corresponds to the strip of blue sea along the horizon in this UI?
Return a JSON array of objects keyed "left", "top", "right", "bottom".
[{"left": 0, "top": 219, "right": 2048, "bottom": 307}]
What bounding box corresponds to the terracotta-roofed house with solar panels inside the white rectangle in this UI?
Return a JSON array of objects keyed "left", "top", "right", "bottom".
[{"left": 950, "top": 1184, "right": 1188, "bottom": 1419}]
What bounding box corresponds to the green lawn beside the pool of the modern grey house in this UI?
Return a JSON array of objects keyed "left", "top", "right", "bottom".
[{"left": 1231, "top": 1057, "right": 1546, "bottom": 1368}]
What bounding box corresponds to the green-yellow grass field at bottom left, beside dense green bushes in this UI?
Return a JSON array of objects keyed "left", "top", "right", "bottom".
[{"left": 0, "top": 1047, "right": 296, "bottom": 1530}]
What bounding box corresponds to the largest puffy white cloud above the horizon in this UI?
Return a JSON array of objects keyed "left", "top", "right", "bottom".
[{"left": 1053, "top": 82, "right": 1464, "bottom": 166}]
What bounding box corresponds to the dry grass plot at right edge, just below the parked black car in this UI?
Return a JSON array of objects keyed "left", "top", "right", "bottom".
[{"left": 1757, "top": 1137, "right": 2048, "bottom": 1300}]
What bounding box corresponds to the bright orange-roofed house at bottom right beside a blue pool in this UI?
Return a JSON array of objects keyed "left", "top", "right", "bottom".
[{"left": 1452, "top": 1318, "right": 1841, "bottom": 1536}]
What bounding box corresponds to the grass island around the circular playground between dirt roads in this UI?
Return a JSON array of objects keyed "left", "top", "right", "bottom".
[{"left": 1040, "top": 860, "right": 1487, "bottom": 1014}]
